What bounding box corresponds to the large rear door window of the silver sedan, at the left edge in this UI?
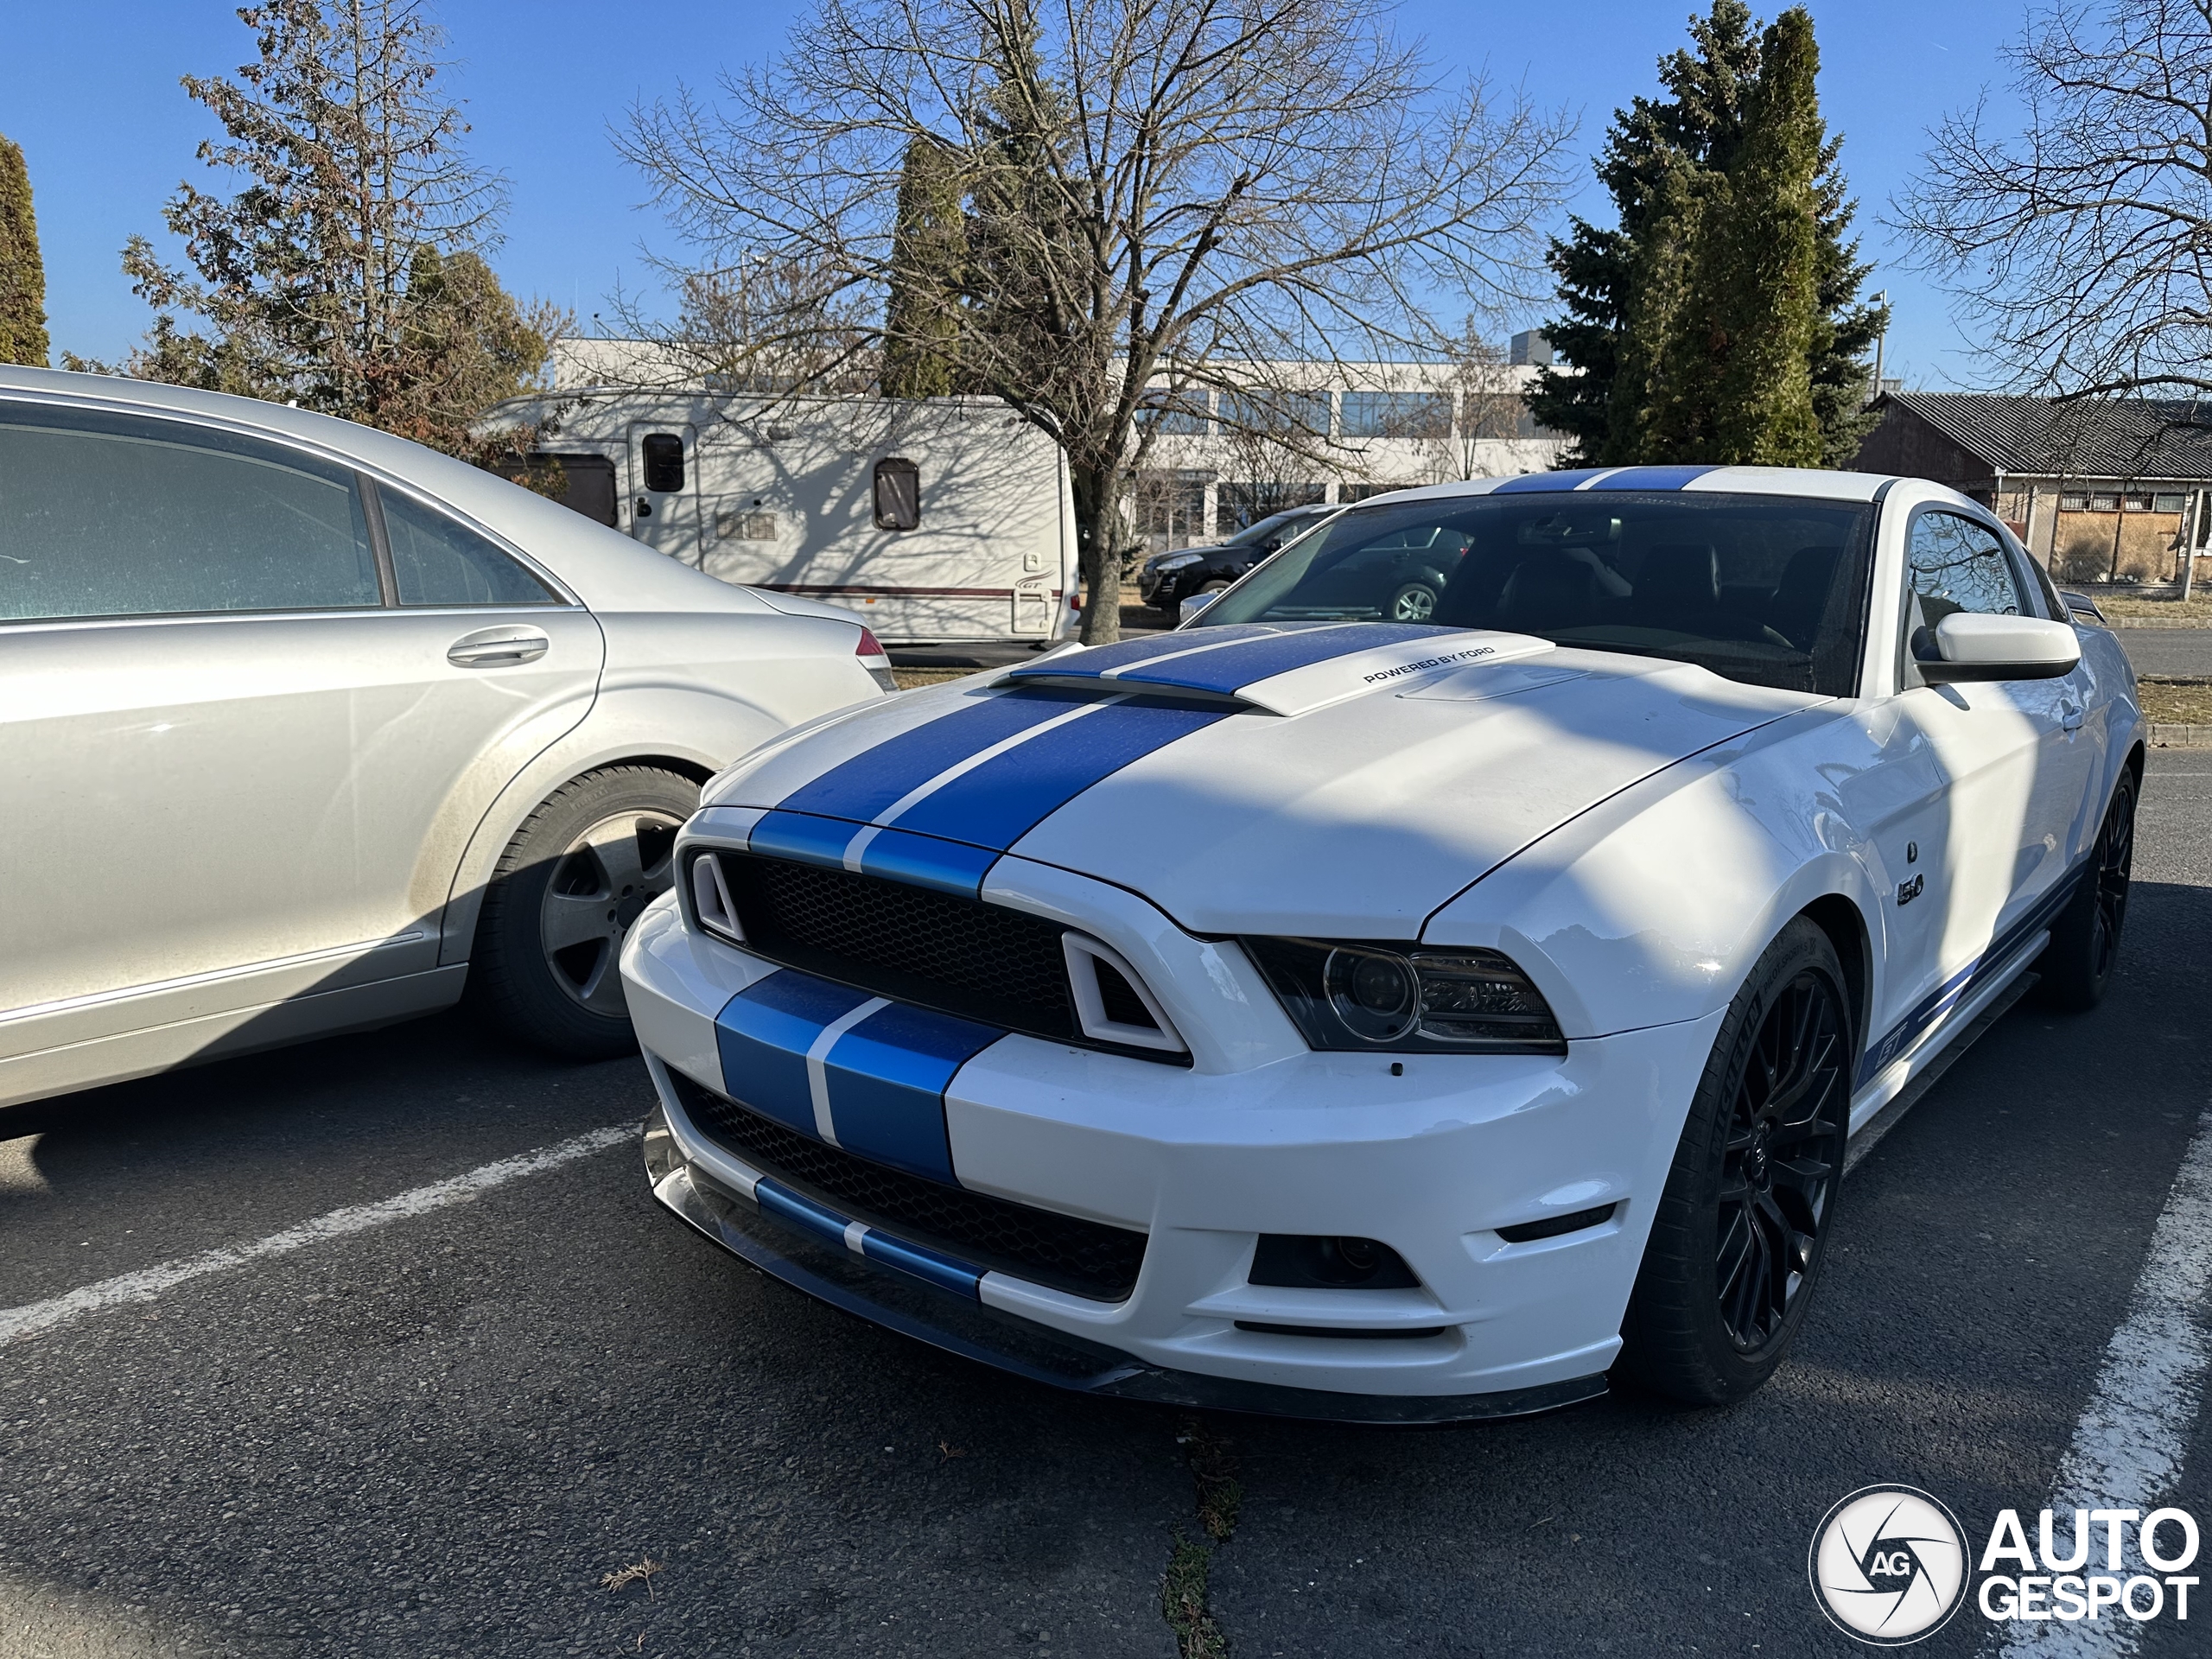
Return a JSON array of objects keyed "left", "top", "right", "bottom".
[{"left": 0, "top": 403, "right": 383, "bottom": 621}]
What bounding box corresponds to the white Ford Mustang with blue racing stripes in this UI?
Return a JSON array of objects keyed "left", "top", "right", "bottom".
[{"left": 624, "top": 467, "right": 2141, "bottom": 1421}]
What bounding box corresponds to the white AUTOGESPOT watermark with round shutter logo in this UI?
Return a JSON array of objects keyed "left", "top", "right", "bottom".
[{"left": 1808, "top": 1486, "right": 2199, "bottom": 1648}]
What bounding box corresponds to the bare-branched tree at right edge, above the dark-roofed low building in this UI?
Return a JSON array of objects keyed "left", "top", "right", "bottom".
[{"left": 1889, "top": 0, "right": 2212, "bottom": 396}]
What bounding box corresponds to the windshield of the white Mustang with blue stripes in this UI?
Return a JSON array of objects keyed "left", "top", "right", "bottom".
[{"left": 1194, "top": 491, "right": 1873, "bottom": 696}]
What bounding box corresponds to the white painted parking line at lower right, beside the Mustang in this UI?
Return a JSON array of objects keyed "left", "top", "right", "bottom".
[{"left": 2002, "top": 1110, "right": 2212, "bottom": 1659}]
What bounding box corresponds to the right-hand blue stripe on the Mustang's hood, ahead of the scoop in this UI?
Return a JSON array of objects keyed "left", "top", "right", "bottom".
[{"left": 898, "top": 703, "right": 1228, "bottom": 852}]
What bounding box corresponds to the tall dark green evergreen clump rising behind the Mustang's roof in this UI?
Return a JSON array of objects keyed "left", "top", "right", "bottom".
[{"left": 1529, "top": 0, "right": 1887, "bottom": 467}]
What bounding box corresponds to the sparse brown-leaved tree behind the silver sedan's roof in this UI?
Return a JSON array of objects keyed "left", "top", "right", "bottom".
[{"left": 86, "top": 0, "right": 566, "bottom": 460}]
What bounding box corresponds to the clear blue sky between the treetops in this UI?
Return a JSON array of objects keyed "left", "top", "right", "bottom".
[{"left": 0, "top": 0, "right": 2026, "bottom": 387}]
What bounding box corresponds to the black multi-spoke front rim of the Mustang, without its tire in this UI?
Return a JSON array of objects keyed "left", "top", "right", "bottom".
[{"left": 1712, "top": 969, "right": 1849, "bottom": 1354}]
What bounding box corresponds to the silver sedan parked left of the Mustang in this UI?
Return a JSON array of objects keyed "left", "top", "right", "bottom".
[{"left": 0, "top": 367, "right": 889, "bottom": 1106}]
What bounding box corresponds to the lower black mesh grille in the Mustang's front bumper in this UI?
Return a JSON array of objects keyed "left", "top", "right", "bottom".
[{"left": 668, "top": 1071, "right": 1146, "bottom": 1303}]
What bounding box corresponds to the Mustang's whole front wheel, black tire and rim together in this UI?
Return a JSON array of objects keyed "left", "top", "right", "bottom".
[{"left": 1619, "top": 916, "right": 1853, "bottom": 1405}]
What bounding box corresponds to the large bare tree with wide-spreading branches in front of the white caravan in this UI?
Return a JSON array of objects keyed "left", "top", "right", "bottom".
[{"left": 620, "top": 0, "right": 1571, "bottom": 641}]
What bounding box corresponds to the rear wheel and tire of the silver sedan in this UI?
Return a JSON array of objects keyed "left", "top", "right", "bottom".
[{"left": 469, "top": 766, "right": 699, "bottom": 1059}]
